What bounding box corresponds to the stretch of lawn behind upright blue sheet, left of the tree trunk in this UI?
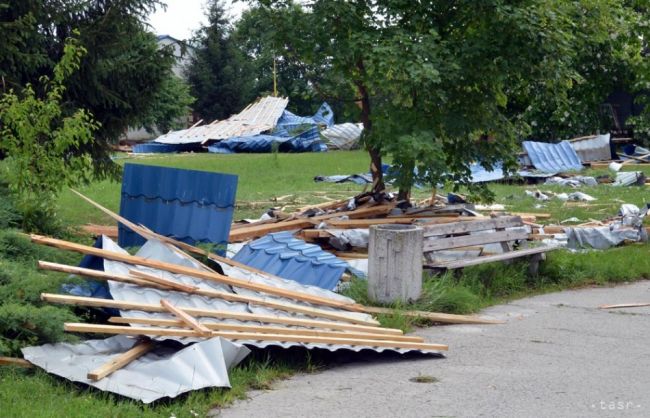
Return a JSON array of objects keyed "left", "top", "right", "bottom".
[{"left": 58, "top": 151, "right": 369, "bottom": 225}]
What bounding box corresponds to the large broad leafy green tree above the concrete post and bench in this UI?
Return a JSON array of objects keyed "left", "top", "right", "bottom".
[{"left": 258, "top": 0, "right": 644, "bottom": 197}]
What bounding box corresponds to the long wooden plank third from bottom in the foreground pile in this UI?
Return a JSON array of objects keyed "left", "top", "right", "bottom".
[{"left": 41, "top": 293, "right": 403, "bottom": 335}]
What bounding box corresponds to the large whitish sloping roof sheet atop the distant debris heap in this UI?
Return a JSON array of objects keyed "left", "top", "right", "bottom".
[{"left": 155, "top": 96, "right": 289, "bottom": 144}]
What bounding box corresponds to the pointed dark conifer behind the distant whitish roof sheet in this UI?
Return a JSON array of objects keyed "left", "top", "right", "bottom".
[{"left": 187, "top": 0, "right": 255, "bottom": 121}]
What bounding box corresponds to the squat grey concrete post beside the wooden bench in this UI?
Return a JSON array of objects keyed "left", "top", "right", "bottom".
[{"left": 368, "top": 225, "right": 423, "bottom": 303}]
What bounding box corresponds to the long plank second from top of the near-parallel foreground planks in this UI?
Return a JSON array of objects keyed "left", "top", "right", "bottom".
[{"left": 39, "top": 262, "right": 377, "bottom": 325}]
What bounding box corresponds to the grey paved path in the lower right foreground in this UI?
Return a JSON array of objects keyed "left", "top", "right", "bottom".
[{"left": 220, "top": 281, "right": 650, "bottom": 418}]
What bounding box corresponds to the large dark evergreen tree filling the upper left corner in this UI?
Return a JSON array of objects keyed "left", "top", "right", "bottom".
[{"left": 0, "top": 0, "right": 174, "bottom": 177}]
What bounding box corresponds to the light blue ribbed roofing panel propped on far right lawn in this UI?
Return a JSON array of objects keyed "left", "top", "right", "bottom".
[{"left": 522, "top": 141, "right": 582, "bottom": 173}]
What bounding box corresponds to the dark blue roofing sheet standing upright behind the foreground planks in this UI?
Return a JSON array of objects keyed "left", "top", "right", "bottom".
[{"left": 119, "top": 164, "right": 237, "bottom": 254}]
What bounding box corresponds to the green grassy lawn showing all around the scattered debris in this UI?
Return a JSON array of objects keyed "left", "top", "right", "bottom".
[{"left": 0, "top": 151, "right": 650, "bottom": 417}]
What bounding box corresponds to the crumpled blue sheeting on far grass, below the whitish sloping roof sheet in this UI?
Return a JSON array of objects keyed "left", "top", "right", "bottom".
[{"left": 208, "top": 125, "right": 327, "bottom": 154}]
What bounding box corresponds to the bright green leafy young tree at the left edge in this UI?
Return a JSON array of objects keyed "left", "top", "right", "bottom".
[{"left": 0, "top": 38, "right": 99, "bottom": 232}]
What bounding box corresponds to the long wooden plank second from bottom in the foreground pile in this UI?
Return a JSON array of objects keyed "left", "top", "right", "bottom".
[{"left": 108, "top": 316, "right": 424, "bottom": 342}]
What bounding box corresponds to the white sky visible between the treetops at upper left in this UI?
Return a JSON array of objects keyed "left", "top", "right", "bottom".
[{"left": 149, "top": 0, "right": 248, "bottom": 40}]
